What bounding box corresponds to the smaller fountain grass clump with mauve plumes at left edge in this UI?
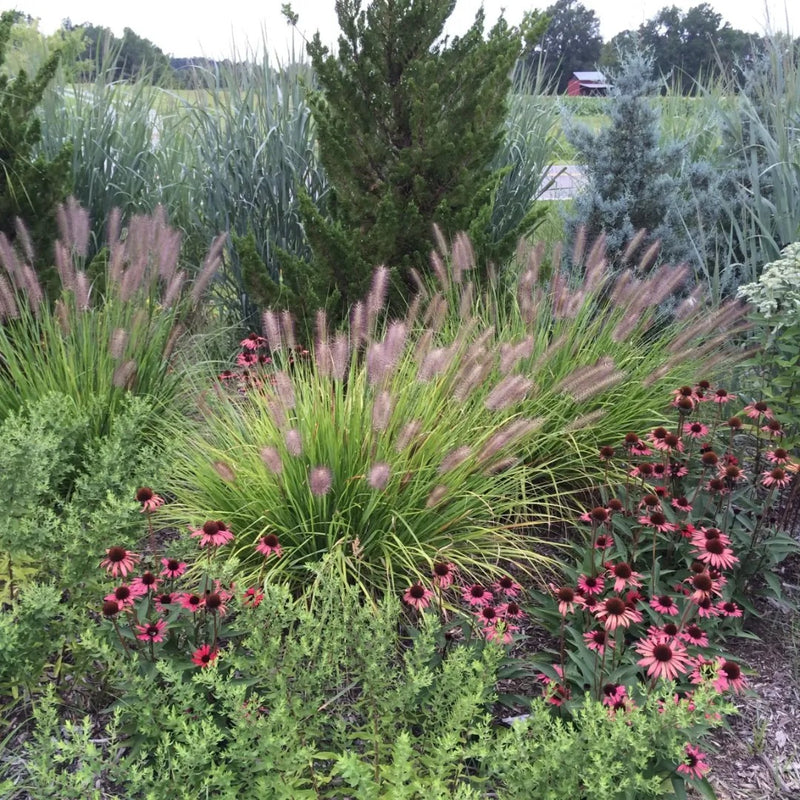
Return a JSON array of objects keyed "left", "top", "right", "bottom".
[{"left": 0, "top": 200, "right": 224, "bottom": 434}]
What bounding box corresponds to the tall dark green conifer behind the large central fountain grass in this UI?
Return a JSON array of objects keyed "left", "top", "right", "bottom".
[{"left": 272, "top": 0, "right": 544, "bottom": 322}]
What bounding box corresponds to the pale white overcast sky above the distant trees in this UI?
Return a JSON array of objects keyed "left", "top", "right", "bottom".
[{"left": 7, "top": 0, "right": 800, "bottom": 60}]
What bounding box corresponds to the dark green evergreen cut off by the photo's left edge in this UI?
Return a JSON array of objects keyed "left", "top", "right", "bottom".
[{"left": 0, "top": 11, "right": 70, "bottom": 276}]
